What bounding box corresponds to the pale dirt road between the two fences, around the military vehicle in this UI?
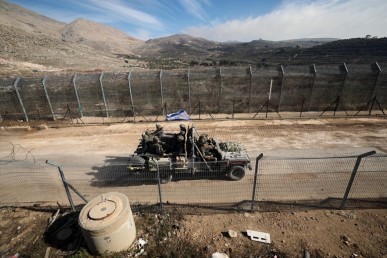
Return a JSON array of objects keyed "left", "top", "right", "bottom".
[{"left": 0, "top": 118, "right": 387, "bottom": 208}]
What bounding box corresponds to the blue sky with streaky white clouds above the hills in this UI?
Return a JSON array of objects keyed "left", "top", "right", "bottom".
[{"left": 8, "top": 0, "right": 387, "bottom": 42}]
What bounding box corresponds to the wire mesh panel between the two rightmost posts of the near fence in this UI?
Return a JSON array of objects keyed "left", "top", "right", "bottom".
[{"left": 256, "top": 157, "right": 356, "bottom": 205}]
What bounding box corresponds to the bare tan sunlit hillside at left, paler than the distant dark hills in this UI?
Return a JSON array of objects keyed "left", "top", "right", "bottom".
[{"left": 0, "top": 0, "right": 144, "bottom": 76}]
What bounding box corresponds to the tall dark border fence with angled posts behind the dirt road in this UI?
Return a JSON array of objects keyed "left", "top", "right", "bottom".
[{"left": 0, "top": 62, "right": 387, "bottom": 122}]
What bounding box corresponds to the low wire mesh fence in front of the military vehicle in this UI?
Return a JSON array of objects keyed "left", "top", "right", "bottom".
[{"left": 0, "top": 152, "right": 387, "bottom": 211}]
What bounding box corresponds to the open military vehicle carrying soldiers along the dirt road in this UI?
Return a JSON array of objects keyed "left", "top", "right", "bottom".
[{"left": 128, "top": 124, "right": 252, "bottom": 183}]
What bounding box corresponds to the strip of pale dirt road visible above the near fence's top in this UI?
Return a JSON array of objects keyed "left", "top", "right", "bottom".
[{"left": 0, "top": 118, "right": 387, "bottom": 163}]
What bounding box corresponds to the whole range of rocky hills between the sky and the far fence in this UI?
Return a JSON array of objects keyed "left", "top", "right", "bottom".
[{"left": 0, "top": 0, "right": 387, "bottom": 77}]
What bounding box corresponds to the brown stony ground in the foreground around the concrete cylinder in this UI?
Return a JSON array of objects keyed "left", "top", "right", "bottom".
[{"left": 0, "top": 208, "right": 387, "bottom": 258}]
